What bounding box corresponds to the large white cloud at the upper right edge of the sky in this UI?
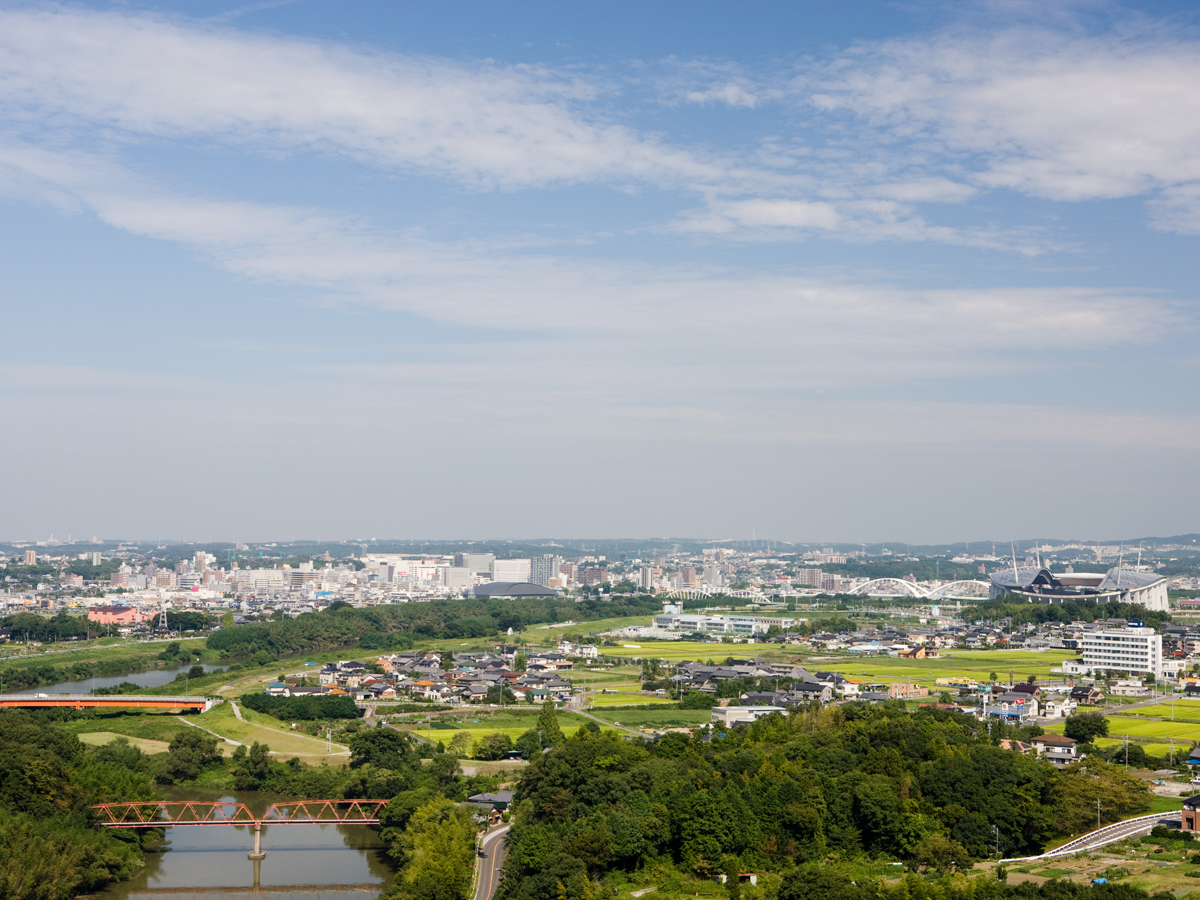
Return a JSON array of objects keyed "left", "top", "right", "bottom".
[{"left": 799, "top": 29, "right": 1200, "bottom": 220}]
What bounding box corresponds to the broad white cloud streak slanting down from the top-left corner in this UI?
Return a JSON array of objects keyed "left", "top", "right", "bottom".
[{"left": 0, "top": 7, "right": 725, "bottom": 186}]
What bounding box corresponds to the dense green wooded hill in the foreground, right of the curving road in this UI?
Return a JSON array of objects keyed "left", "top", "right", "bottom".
[{"left": 502, "top": 704, "right": 1150, "bottom": 900}]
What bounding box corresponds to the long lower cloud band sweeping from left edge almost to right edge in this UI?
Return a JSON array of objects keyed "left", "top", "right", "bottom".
[{"left": 0, "top": 138, "right": 1171, "bottom": 380}]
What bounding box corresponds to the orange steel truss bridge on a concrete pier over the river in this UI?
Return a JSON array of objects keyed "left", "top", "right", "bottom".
[{"left": 92, "top": 800, "right": 388, "bottom": 859}]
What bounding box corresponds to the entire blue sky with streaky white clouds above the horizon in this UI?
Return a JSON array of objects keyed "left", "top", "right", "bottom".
[{"left": 0, "top": 0, "right": 1200, "bottom": 542}]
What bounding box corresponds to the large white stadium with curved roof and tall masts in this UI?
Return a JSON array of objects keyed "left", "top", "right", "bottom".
[{"left": 989, "top": 565, "right": 1168, "bottom": 611}]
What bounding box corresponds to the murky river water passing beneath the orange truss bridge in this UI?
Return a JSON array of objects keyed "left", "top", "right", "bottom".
[{"left": 92, "top": 787, "right": 392, "bottom": 900}]
